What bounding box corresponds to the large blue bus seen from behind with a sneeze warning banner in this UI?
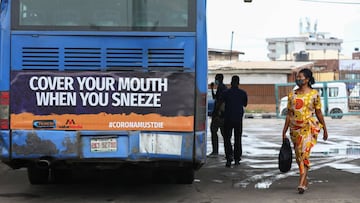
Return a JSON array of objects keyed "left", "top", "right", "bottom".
[{"left": 0, "top": 0, "right": 207, "bottom": 184}]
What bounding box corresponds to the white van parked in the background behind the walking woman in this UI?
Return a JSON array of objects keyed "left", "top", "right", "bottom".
[{"left": 279, "top": 82, "right": 349, "bottom": 119}]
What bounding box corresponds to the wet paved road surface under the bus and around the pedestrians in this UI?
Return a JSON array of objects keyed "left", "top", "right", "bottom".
[{"left": 0, "top": 117, "right": 360, "bottom": 203}]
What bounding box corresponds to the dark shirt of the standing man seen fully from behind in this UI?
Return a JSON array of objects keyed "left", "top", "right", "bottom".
[{"left": 222, "top": 87, "right": 248, "bottom": 121}]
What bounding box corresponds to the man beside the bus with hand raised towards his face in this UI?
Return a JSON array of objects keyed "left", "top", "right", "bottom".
[{"left": 210, "top": 74, "right": 227, "bottom": 156}]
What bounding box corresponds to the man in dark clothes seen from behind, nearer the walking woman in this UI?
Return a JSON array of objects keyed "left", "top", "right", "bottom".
[{"left": 222, "top": 75, "right": 248, "bottom": 167}]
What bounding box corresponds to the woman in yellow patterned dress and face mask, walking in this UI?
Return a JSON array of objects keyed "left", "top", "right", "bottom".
[{"left": 282, "top": 68, "right": 328, "bottom": 194}]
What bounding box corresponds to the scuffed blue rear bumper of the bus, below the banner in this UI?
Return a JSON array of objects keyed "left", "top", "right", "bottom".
[{"left": 0, "top": 130, "right": 206, "bottom": 168}]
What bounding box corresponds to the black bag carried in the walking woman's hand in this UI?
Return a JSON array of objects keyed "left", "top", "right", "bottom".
[{"left": 279, "top": 138, "right": 292, "bottom": 173}]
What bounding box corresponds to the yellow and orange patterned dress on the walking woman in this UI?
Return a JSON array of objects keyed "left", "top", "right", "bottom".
[{"left": 288, "top": 89, "right": 322, "bottom": 174}]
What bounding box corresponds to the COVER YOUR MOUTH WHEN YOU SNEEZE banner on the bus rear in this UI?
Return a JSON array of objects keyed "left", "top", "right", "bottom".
[{"left": 10, "top": 71, "right": 195, "bottom": 131}]
